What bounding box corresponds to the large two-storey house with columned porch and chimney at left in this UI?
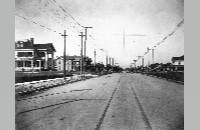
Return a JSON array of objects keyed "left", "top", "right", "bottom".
[{"left": 15, "top": 38, "right": 56, "bottom": 71}]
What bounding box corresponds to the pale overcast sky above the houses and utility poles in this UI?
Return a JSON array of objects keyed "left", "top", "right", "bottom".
[{"left": 15, "top": 0, "right": 184, "bottom": 66}]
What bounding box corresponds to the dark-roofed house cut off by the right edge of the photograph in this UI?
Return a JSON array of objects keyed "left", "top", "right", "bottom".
[{"left": 172, "top": 55, "right": 184, "bottom": 71}]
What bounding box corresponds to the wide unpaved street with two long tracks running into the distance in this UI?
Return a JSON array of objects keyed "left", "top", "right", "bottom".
[{"left": 16, "top": 73, "right": 184, "bottom": 130}]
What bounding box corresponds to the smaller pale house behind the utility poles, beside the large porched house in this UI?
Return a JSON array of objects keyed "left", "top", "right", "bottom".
[{"left": 56, "top": 56, "right": 81, "bottom": 71}]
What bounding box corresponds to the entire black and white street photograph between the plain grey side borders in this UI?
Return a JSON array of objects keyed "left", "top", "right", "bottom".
[{"left": 13, "top": 0, "right": 184, "bottom": 130}]
